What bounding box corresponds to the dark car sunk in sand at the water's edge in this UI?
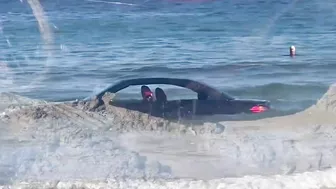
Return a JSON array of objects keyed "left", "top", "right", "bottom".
[{"left": 85, "top": 78, "right": 270, "bottom": 118}]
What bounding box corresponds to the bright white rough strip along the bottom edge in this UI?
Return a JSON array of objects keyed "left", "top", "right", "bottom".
[{"left": 3, "top": 169, "right": 336, "bottom": 189}]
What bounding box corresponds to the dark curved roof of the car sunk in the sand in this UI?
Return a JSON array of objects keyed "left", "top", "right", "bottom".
[{"left": 86, "top": 77, "right": 232, "bottom": 99}]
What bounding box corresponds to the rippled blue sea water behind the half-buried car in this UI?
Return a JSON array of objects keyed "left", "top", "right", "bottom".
[{"left": 0, "top": 0, "right": 336, "bottom": 111}]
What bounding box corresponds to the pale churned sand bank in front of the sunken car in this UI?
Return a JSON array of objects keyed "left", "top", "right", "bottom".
[{"left": 0, "top": 84, "right": 336, "bottom": 188}]
